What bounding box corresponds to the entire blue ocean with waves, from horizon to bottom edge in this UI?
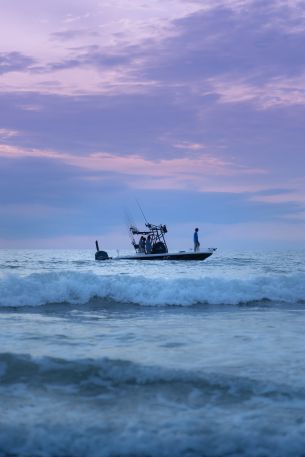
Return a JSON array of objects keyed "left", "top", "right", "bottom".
[{"left": 0, "top": 250, "right": 305, "bottom": 457}]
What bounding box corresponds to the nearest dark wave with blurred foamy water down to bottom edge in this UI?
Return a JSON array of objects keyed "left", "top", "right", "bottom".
[{"left": 0, "top": 354, "right": 305, "bottom": 457}]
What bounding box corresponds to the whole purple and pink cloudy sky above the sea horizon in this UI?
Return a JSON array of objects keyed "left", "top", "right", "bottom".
[{"left": 0, "top": 0, "right": 305, "bottom": 250}]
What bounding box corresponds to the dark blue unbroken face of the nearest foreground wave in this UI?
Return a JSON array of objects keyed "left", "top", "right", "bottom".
[{"left": 0, "top": 353, "right": 305, "bottom": 400}]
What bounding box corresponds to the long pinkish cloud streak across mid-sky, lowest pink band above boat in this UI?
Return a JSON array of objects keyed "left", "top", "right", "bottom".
[{"left": 0, "top": 140, "right": 270, "bottom": 193}]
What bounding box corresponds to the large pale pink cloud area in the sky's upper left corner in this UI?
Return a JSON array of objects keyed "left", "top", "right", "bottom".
[{"left": 0, "top": 0, "right": 204, "bottom": 95}]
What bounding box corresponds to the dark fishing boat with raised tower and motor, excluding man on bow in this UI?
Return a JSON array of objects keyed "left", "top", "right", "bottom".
[{"left": 95, "top": 222, "right": 216, "bottom": 260}]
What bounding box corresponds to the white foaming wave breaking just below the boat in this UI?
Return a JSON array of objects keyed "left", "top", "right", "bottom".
[{"left": 0, "top": 271, "right": 305, "bottom": 307}]
